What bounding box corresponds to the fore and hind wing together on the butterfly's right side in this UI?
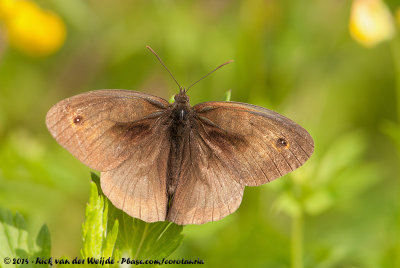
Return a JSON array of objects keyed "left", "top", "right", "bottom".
[{"left": 167, "top": 102, "right": 314, "bottom": 224}]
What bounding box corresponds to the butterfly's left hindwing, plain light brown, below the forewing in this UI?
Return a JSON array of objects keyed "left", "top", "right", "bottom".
[{"left": 100, "top": 117, "right": 170, "bottom": 222}]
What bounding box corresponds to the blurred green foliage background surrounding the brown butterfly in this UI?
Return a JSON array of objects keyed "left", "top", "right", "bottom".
[{"left": 0, "top": 0, "right": 400, "bottom": 268}]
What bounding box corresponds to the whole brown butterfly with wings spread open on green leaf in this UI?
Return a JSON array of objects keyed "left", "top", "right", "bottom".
[{"left": 46, "top": 47, "right": 314, "bottom": 225}]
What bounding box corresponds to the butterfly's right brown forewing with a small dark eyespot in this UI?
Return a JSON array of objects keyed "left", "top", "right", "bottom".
[{"left": 194, "top": 99, "right": 314, "bottom": 186}]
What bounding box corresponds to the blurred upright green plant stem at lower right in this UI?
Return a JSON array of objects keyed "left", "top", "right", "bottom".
[{"left": 291, "top": 211, "right": 304, "bottom": 268}]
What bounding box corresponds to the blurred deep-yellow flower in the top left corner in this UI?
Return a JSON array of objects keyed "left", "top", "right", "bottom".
[{"left": 0, "top": 0, "right": 66, "bottom": 56}]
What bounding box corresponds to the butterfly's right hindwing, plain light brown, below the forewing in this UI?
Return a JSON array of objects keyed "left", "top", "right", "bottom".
[{"left": 167, "top": 131, "right": 244, "bottom": 225}]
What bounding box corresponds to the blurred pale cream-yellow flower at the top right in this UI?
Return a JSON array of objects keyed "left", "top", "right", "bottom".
[{"left": 349, "top": 0, "right": 395, "bottom": 47}]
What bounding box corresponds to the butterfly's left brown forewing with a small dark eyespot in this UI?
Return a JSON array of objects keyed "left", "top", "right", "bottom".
[{"left": 46, "top": 90, "right": 168, "bottom": 171}]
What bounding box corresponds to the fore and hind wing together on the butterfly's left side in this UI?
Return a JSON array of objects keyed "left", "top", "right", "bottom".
[{"left": 46, "top": 90, "right": 170, "bottom": 222}]
